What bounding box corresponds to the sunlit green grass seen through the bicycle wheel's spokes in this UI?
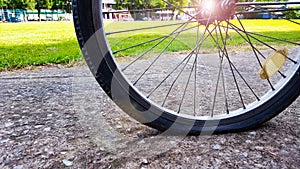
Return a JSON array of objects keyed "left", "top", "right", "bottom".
[{"left": 105, "top": 20, "right": 300, "bottom": 57}]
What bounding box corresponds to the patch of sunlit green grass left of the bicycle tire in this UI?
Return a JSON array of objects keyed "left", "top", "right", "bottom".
[{"left": 0, "top": 22, "right": 81, "bottom": 70}]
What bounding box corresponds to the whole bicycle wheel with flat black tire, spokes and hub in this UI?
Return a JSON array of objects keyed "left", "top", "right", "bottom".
[{"left": 73, "top": 0, "right": 300, "bottom": 134}]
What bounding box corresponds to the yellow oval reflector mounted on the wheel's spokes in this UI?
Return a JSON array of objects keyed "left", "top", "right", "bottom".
[{"left": 258, "top": 48, "right": 288, "bottom": 79}]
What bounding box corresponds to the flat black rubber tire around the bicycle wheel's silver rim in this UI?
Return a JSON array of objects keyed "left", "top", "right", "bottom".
[{"left": 73, "top": 0, "right": 300, "bottom": 134}]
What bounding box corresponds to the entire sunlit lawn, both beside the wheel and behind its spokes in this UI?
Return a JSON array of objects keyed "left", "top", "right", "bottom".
[{"left": 0, "top": 20, "right": 300, "bottom": 71}]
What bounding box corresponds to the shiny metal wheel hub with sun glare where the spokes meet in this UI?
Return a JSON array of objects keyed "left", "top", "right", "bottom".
[{"left": 197, "top": 0, "right": 237, "bottom": 25}]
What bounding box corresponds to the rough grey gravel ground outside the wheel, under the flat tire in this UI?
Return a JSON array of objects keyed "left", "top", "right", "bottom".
[{"left": 0, "top": 63, "right": 300, "bottom": 169}]
